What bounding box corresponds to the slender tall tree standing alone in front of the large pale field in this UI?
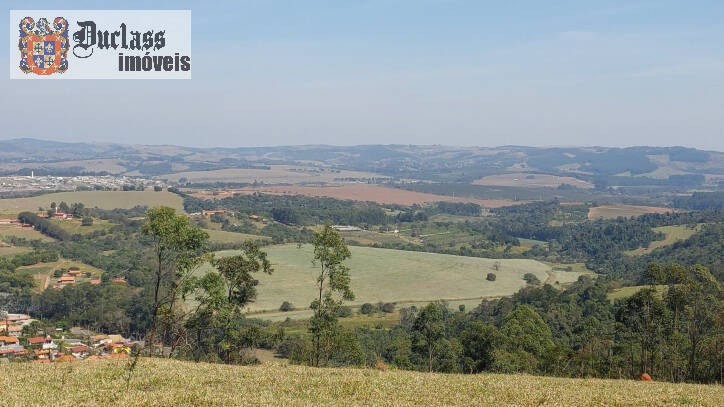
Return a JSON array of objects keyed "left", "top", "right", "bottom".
[{"left": 309, "top": 225, "right": 354, "bottom": 366}]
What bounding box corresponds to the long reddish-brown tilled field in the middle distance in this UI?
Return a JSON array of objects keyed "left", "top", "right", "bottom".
[{"left": 192, "top": 184, "right": 522, "bottom": 208}]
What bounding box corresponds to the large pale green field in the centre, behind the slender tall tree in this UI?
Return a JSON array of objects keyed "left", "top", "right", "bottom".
[{"left": 195, "top": 245, "right": 583, "bottom": 312}]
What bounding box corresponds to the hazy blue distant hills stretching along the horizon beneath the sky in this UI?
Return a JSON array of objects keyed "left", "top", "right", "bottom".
[{"left": 0, "top": 138, "right": 724, "bottom": 185}]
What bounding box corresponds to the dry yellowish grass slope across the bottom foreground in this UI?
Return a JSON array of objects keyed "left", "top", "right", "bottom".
[{"left": 0, "top": 359, "right": 722, "bottom": 407}]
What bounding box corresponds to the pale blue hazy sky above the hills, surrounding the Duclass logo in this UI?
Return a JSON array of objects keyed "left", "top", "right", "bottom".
[{"left": 0, "top": 0, "right": 724, "bottom": 151}]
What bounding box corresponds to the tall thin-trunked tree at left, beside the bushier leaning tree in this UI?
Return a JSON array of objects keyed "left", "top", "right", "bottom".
[{"left": 141, "top": 206, "right": 209, "bottom": 354}]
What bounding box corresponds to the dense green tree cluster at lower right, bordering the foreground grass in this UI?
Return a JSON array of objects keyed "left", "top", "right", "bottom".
[{"left": 277, "top": 264, "right": 724, "bottom": 383}]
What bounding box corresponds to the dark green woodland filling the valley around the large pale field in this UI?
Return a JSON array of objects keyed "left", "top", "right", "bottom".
[{"left": 0, "top": 195, "right": 724, "bottom": 382}]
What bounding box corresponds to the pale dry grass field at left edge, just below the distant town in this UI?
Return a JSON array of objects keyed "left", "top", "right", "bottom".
[{"left": 0, "top": 191, "right": 183, "bottom": 212}]
